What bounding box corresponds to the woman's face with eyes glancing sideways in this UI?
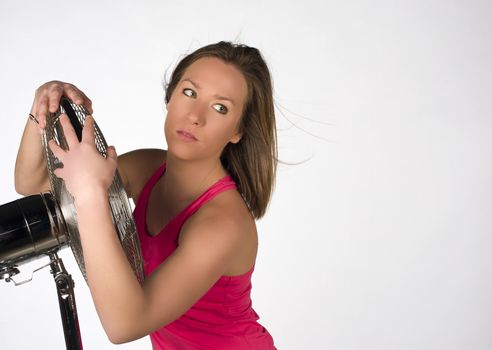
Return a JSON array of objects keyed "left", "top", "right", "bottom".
[{"left": 164, "top": 57, "right": 247, "bottom": 160}]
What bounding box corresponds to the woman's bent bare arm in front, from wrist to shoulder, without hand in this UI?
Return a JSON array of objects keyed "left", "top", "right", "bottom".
[{"left": 77, "top": 191, "right": 244, "bottom": 344}]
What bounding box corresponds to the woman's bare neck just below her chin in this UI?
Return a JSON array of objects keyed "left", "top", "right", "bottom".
[{"left": 162, "top": 153, "right": 227, "bottom": 202}]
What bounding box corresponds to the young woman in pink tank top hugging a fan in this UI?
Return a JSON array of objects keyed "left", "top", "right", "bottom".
[{"left": 15, "top": 42, "right": 277, "bottom": 349}]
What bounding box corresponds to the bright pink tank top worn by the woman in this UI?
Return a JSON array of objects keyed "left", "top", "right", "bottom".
[{"left": 133, "top": 163, "right": 275, "bottom": 350}]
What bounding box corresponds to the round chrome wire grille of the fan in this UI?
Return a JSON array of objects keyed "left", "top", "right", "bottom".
[{"left": 43, "top": 100, "right": 144, "bottom": 284}]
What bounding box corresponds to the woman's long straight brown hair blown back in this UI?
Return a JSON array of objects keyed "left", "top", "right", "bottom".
[{"left": 166, "top": 41, "right": 277, "bottom": 219}]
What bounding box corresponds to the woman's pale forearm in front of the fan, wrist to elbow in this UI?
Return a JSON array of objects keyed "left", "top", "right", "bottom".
[{"left": 76, "top": 190, "right": 145, "bottom": 343}]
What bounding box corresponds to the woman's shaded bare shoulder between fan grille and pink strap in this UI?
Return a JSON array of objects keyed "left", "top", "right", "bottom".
[{"left": 118, "top": 148, "right": 166, "bottom": 200}]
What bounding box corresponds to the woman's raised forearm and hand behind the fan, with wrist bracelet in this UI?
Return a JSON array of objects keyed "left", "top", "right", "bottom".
[{"left": 14, "top": 81, "right": 92, "bottom": 196}]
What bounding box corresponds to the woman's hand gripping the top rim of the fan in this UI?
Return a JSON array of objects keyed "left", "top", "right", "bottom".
[{"left": 31, "top": 80, "right": 93, "bottom": 133}]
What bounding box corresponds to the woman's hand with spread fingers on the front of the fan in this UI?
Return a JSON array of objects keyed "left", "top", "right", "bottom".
[{"left": 48, "top": 114, "right": 117, "bottom": 204}]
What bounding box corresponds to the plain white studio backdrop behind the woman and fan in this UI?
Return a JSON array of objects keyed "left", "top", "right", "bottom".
[{"left": 0, "top": 0, "right": 492, "bottom": 350}]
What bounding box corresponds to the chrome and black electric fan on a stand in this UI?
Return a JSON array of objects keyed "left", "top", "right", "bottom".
[{"left": 0, "top": 98, "right": 144, "bottom": 349}]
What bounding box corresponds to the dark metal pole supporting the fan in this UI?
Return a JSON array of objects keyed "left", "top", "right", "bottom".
[{"left": 49, "top": 252, "right": 82, "bottom": 350}]
